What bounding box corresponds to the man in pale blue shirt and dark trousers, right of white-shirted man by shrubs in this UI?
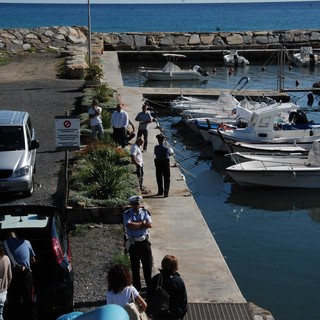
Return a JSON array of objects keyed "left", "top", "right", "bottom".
[{"left": 111, "top": 103, "right": 129, "bottom": 148}]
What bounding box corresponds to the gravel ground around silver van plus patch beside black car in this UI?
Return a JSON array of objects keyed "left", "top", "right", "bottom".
[{"left": 0, "top": 53, "right": 123, "bottom": 320}]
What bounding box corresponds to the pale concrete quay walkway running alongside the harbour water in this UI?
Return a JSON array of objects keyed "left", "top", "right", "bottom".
[{"left": 102, "top": 52, "right": 270, "bottom": 320}]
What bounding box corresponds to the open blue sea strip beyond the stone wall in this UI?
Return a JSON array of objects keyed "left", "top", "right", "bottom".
[{"left": 0, "top": 1, "right": 320, "bottom": 32}]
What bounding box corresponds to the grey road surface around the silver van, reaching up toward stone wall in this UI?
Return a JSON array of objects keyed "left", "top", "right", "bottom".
[{"left": 0, "top": 54, "right": 83, "bottom": 206}]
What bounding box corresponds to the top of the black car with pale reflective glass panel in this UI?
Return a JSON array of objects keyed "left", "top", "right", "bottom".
[{"left": 0, "top": 205, "right": 57, "bottom": 230}]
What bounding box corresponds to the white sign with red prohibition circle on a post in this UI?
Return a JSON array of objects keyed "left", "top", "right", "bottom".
[{"left": 55, "top": 116, "right": 80, "bottom": 149}]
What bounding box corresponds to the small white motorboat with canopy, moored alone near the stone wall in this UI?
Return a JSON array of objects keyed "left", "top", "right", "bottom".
[{"left": 139, "top": 53, "right": 209, "bottom": 81}]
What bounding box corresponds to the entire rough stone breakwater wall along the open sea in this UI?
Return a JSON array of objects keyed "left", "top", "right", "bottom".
[{"left": 0, "top": 26, "right": 320, "bottom": 52}]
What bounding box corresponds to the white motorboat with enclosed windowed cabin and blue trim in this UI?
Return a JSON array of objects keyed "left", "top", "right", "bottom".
[{"left": 209, "top": 102, "right": 320, "bottom": 151}]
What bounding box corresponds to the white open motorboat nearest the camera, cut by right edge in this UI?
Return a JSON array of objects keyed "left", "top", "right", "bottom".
[{"left": 226, "top": 141, "right": 320, "bottom": 189}]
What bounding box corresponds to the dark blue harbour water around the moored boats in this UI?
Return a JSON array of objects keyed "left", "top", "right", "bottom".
[{"left": 121, "top": 61, "right": 320, "bottom": 320}]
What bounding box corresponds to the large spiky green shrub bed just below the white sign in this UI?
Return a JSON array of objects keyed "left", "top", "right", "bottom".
[{"left": 69, "top": 141, "right": 137, "bottom": 207}]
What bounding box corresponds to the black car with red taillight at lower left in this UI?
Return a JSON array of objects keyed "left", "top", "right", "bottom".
[{"left": 0, "top": 205, "right": 74, "bottom": 319}]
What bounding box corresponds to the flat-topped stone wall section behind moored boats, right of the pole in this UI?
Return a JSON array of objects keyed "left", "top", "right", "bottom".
[{"left": 103, "top": 30, "right": 320, "bottom": 51}]
